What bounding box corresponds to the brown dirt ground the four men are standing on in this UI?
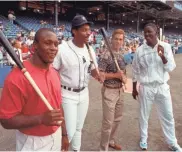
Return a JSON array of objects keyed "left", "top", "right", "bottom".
[{"left": 0, "top": 55, "right": 182, "bottom": 151}]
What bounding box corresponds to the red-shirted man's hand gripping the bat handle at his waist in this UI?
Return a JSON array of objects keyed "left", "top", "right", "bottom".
[{"left": 41, "top": 109, "right": 64, "bottom": 126}]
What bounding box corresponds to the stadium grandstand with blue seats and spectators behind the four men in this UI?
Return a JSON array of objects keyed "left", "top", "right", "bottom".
[{"left": 0, "top": 0, "right": 182, "bottom": 86}]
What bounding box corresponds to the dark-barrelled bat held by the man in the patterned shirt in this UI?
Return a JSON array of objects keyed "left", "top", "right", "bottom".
[{"left": 100, "top": 27, "right": 126, "bottom": 89}]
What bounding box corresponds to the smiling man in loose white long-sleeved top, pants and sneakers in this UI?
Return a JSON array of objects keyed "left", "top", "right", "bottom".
[{"left": 132, "top": 23, "right": 182, "bottom": 152}]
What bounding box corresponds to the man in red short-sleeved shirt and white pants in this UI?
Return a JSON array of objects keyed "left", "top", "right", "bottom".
[{"left": 0, "top": 28, "right": 69, "bottom": 151}]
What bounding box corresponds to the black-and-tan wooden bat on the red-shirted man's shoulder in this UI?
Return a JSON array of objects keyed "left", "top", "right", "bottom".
[{"left": 0, "top": 30, "right": 61, "bottom": 123}]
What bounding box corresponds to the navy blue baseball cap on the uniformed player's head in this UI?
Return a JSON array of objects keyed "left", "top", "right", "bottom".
[{"left": 72, "top": 15, "right": 93, "bottom": 27}]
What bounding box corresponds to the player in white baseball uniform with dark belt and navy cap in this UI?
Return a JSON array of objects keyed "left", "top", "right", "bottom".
[{"left": 53, "top": 15, "right": 98, "bottom": 151}]
